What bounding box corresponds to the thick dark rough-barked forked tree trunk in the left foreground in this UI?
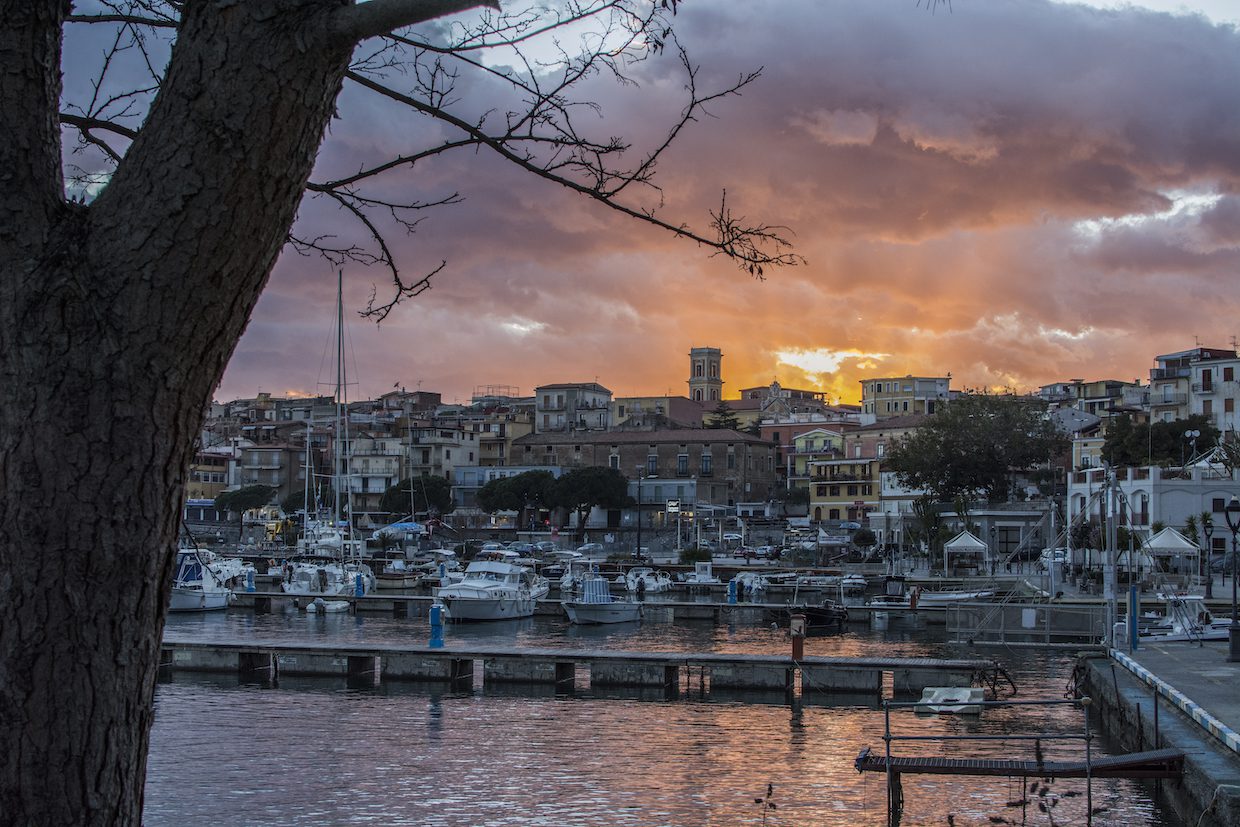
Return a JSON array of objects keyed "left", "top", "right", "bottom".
[{"left": 0, "top": 0, "right": 351, "bottom": 825}]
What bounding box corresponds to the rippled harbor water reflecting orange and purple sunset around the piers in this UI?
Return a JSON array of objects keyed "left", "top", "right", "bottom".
[{"left": 144, "top": 611, "right": 1179, "bottom": 827}]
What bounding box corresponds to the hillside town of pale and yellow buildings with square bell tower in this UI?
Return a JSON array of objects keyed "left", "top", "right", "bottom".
[{"left": 185, "top": 347, "right": 1240, "bottom": 570}]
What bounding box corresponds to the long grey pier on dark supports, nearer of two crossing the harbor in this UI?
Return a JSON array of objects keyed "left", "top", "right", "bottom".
[{"left": 160, "top": 636, "right": 994, "bottom": 698}]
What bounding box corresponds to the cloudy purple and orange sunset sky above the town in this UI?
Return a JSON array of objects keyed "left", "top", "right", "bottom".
[{"left": 106, "top": 0, "right": 1240, "bottom": 403}]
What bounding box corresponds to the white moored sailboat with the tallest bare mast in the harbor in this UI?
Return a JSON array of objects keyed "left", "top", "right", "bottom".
[{"left": 280, "top": 270, "right": 374, "bottom": 598}]
